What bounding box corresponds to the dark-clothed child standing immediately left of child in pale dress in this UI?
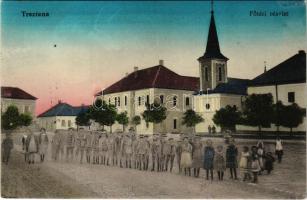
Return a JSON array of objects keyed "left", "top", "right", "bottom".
[{"left": 226, "top": 139, "right": 238, "bottom": 180}]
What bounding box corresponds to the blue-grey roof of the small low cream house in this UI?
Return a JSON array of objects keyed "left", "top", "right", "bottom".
[{"left": 37, "top": 102, "right": 88, "bottom": 117}]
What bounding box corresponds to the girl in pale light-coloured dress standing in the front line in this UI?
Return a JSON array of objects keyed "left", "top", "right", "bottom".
[{"left": 180, "top": 137, "right": 192, "bottom": 176}]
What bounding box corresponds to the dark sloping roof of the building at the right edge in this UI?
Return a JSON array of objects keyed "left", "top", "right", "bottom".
[{"left": 250, "top": 50, "right": 306, "bottom": 86}]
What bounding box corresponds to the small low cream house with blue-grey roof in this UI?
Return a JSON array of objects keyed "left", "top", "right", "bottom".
[{"left": 37, "top": 101, "right": 88, "bottom": 131}]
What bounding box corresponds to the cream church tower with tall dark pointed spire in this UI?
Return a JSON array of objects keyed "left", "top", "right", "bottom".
[{"left": 198, "top": 1, "right": 228, "bottom": 91}]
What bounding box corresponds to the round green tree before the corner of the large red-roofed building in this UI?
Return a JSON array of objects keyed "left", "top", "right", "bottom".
[{"left": 142, "top": 102, "right": 166, "bottom": 127}]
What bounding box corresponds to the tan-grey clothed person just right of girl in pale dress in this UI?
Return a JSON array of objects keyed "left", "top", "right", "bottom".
[{"left": 192, "top": 136, "right": 203, "bottom": 177}]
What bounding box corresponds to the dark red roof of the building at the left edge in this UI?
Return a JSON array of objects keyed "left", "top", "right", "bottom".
[{"left": 1, "top": 86, "right": 37, "bottom": 100}]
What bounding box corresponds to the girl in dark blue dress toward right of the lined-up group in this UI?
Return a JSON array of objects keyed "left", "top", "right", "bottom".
[{"left": 204, "top": 139, "right": 215, "bottom": 180}]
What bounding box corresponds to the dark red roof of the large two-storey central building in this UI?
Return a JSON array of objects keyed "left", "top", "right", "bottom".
[{"left": 101, "top": 65, "right": 199, "bottom": 96}]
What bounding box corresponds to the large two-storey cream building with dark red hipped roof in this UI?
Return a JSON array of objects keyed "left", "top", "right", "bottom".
[{"left": 98, "top": 61, "right": 199, "bottom": 134}]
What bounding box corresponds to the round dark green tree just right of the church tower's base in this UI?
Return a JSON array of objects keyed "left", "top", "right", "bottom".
[{"left": 213, "top": 105, "right": 241, "bottom": 131}]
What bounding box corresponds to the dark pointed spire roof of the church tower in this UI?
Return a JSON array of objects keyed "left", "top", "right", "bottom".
[{"left": 199, "top": 11, "right": 228, "bottom": 60}]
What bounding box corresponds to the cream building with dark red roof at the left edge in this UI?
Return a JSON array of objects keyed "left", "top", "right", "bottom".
[{"left": 1, "top": 86, "right": 37, "bottom": 118}]
